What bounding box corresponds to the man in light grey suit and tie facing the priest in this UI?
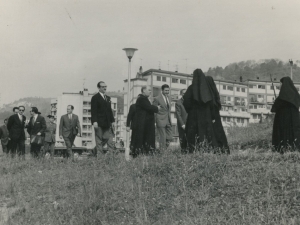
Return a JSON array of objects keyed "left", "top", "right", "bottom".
[{"left": 153, "top": 84, "right": 173, "bottom": 149}]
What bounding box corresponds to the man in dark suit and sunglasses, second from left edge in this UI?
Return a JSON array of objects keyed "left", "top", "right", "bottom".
[{"left": 7, "top": 106, "right": 26, "bottom": 159}]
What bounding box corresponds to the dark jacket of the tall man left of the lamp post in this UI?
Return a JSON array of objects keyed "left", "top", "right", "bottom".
[{"left": 91, "top": 92, "right": 115, "bottom": 128}]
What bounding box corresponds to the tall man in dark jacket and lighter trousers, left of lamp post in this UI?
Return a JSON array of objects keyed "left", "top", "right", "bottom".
[{"left": 91, "top": 81, "right": 115, "bottom": 156}]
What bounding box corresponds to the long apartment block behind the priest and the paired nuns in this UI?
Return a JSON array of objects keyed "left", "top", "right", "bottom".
[{"left": 124, "top": 69, "right": 250, "bottom": 144}]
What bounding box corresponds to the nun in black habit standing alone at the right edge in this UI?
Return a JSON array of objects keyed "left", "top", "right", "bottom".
[{"left": 271, "top": 77, "right": 300, "bottom": 154}]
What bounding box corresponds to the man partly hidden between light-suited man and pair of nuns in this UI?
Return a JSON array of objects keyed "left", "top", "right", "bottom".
[{"left": 175, "top": 89, "right": 188, "bottom": 153}]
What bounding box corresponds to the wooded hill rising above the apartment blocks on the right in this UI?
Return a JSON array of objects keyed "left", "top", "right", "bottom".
[{"left": 205, "top": 59, "right": 300, "bottom": 82}]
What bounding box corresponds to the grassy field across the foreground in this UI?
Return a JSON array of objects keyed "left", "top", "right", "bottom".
[{"left": 0, "top": 124, "right": 300, "bottom": 225}]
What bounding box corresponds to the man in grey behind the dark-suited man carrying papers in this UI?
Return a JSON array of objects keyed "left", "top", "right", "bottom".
[{"left": 44, "top": 115, "right": 56, "bottom": 157}]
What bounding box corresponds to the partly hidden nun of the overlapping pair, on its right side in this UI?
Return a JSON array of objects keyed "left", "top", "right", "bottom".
[{"left": 205, "top": 76, "right": 230, "bottom": 154}]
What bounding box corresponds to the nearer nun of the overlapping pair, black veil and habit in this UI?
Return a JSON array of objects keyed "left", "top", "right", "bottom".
[{"left": 183, "top": 69, "right": 217, "bottom": 152}]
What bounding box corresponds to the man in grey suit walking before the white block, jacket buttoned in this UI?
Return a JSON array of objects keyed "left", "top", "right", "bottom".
[{"left": 59, "top": 105, "right": 81, "bottom": 158}]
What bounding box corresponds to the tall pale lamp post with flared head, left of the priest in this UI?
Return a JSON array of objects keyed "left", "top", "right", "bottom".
[{"left": 123, "top": 48, "right": 137, "bottom": 160}]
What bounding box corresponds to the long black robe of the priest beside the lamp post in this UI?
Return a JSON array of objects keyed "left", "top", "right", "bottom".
[{"left": 130, "top": 94, "right": 158, "bottom": 157}]
